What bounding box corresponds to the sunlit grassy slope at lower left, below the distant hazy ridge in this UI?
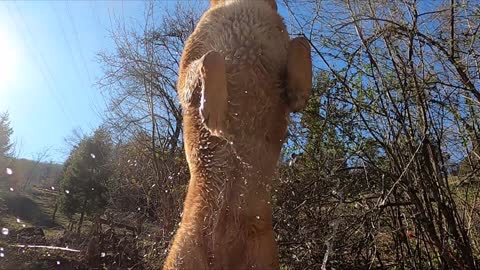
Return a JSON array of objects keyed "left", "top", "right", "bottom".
[{"left": 0, "top": 185, "right": 86, "bottom": 270}]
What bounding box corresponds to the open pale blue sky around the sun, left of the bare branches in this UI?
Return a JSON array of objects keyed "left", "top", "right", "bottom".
[{"left": 0, "top": 1, "right": 163, "bottom": 162}]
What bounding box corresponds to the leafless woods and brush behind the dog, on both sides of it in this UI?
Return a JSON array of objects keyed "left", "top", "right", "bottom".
[{"left": 0, "top": 0, "right": 480, "bottom": 269}]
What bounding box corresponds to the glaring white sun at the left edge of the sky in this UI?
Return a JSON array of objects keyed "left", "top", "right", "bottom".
[{"left": 0, "top": 28, "right": 19, "bottom": 93}]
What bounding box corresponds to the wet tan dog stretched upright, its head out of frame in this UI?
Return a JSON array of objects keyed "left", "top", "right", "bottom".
[{"left": 164, "top": 0, "right": 312, "bottom": 270}]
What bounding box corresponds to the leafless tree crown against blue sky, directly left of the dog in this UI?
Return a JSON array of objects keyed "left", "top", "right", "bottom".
[{"left": 98, "top": 2, "right": 200, "bottom": 156}]
